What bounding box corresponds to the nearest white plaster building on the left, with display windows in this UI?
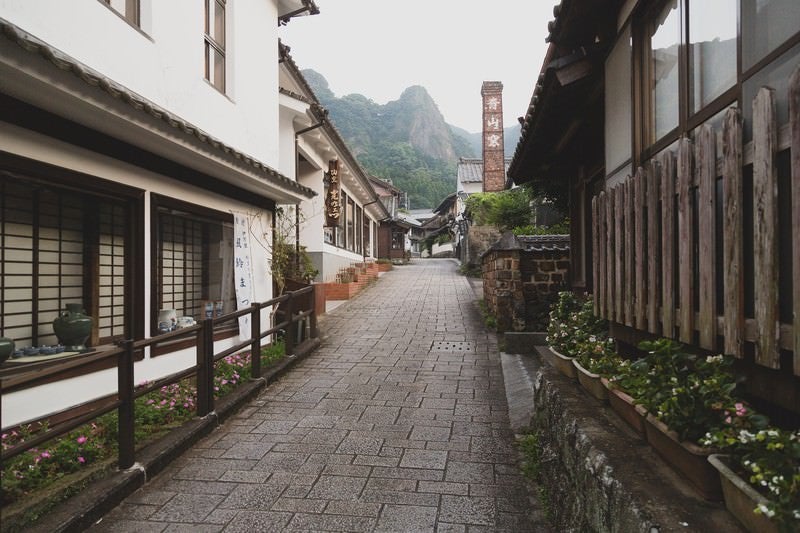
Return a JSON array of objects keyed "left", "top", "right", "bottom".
[{"left": 0, "top": 0, "right": 318, "bottom": 427}]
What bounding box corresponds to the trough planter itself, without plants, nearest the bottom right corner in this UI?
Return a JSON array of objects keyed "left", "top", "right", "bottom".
[{"left": 708, "top": 454, "right": 778, "bottom": 533}]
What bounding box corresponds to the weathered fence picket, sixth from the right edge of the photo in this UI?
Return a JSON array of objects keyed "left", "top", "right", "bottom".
[{"left": 661, "top": 150, "right": 675, "bottom": 339}]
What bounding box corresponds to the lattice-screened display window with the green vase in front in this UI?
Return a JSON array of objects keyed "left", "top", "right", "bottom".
[{"left": 0, "top": 175, "right": 131, "bottom": 348}]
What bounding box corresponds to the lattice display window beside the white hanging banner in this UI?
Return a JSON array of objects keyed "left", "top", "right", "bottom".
[{"left": 152, "top": 195, "right": 236, "bottom": 333}]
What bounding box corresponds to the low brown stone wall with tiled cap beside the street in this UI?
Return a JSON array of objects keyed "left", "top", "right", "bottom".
[{"left": 482, "top": 232, "right": 569, "bottom": 331}]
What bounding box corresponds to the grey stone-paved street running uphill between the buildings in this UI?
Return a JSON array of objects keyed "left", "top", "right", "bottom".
[{"left": 93, "top": 259, "right": 545, "bottom": 532}]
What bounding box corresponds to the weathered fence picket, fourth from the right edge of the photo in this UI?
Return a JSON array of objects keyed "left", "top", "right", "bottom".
[{"left": 696, "top": 124, "right": 717, "bottom": 350}]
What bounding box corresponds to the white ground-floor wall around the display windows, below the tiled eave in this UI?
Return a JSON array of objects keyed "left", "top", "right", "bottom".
[{"left": 0, "top": 122, "right": 272, "bottom": 427}]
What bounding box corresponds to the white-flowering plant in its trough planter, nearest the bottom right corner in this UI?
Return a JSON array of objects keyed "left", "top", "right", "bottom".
[{"left": 703, "top": 424, "right": 800, "bottom": 533}]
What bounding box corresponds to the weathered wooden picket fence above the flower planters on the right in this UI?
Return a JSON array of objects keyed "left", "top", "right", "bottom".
[{"left": 592, "top": 69, "right": 800, "bottom": 376}]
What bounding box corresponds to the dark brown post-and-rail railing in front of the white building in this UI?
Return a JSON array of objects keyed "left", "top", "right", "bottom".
[{"left": 0, "top": 285, "right": 317, "bottom": 469}]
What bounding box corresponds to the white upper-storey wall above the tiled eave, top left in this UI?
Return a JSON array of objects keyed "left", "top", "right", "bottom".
[{"left": 0, "top": 0, "right": 278, "bottom": 168}]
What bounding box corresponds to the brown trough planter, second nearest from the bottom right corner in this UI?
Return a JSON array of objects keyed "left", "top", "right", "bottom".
[{"left": 645, "top": 415, "right": 722, "bottom": 501}]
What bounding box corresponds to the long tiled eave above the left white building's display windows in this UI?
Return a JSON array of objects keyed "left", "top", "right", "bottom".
[{"left": 0, "top": 18, "right": 317, "bottom": 198}]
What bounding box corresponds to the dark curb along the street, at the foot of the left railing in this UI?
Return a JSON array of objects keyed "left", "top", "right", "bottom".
[{"left": 27, "top": 338, "right": 320, "bottom": 533}]
